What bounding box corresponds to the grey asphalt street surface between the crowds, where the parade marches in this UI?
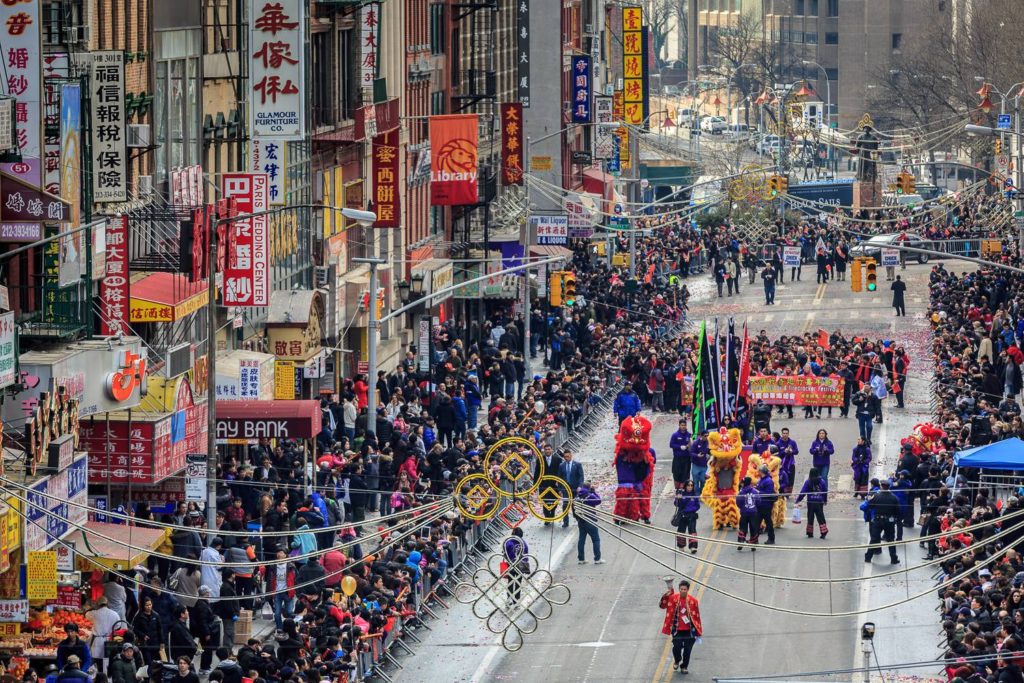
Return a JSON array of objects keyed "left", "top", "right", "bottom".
[{"left": 398, "top": 265, "right": 938, "bottom": 682}]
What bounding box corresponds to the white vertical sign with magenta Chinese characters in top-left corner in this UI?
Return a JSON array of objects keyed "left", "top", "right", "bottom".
[{"left": 0, "top": 0, "right": 43, "bottom": 187}]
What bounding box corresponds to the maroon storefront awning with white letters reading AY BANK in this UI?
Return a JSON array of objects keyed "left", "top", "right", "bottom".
[{"left": 217, "top": 400, "right": 322, "bottom": 439}]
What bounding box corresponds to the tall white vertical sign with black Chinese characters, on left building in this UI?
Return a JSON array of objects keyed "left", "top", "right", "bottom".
[{"left": 90, "top": 50, "right": 128, "bottom": 203}]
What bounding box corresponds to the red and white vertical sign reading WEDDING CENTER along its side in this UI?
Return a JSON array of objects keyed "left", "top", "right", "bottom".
[{"left": 221, "top": 173, "right": 270, "bottom": 306}]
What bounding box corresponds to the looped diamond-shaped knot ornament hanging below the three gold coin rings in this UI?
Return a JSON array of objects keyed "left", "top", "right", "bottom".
[{"left": 455, "top": 537, "right": 572, "bottom": 652}]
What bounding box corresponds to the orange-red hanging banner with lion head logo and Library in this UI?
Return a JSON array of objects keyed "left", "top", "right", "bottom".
[{"left": 430, "top": 114, "right": 478, "bottom": 206}]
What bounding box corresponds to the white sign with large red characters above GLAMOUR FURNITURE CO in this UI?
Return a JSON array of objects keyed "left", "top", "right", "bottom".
[{"left": 249, "top": 0, "right": 306, "bottom": 140}]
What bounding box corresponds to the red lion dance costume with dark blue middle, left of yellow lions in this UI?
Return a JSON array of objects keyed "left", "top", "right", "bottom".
[{"left": 612, "top": 415, "right": 655, "bottom": 522}]
